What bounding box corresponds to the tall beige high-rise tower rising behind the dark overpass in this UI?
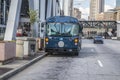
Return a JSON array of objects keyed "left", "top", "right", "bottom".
[{"left": 89, "top": 0, "right": 104, "bottom": 20}]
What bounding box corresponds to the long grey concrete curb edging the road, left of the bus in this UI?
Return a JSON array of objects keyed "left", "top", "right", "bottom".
[{"left": 0, "top": 53, "right": 47, "bottom": 80}]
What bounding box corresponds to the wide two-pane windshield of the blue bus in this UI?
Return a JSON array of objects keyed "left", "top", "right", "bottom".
[{"left": 46, "top": 23, "right": 79, "bottom": 37}]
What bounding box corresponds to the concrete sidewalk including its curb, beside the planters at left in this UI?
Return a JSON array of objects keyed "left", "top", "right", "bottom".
[{"left": 0, "top": 51, "right": 47, "bottom": 80}]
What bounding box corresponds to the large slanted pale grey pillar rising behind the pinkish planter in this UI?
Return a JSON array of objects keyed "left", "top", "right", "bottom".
[{"left": 4, "top": 0, "right": 22, "bottom": 41}]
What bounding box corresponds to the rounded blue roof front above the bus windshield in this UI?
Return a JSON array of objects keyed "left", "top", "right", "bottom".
[{"left": 46, "top": 16, "right": 79, "bottom": 23}]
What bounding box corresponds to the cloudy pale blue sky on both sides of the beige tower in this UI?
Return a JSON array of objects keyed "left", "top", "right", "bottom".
[{"left": 73, "top": 0, "right": 116, "bottom": 19}]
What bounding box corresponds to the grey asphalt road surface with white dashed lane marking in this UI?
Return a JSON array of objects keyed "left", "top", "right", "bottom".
[{"left": 9, "top": 39, "right": 120, "bottom": 80}]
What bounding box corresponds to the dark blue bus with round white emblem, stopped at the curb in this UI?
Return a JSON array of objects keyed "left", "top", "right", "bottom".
[{"left": 44, "top": 16, "right": 82, "bottom": 55}]
